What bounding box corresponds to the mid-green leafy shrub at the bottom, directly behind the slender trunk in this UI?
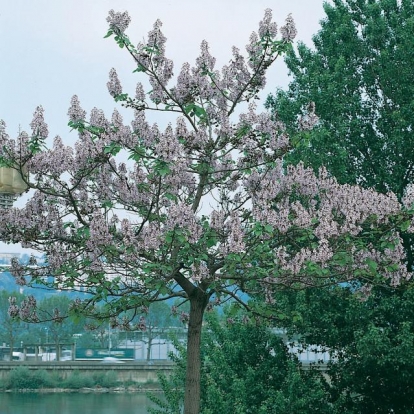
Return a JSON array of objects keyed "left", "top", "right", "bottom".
[{"left": 150, "top": 315, "right": 335, "bottom": 414}]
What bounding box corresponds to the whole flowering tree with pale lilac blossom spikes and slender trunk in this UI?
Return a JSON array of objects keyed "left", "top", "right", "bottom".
[{"left": 0, "top": 10, "right": 412, "bottom": 414}]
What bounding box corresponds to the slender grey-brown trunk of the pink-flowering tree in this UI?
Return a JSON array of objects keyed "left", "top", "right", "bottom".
[{"left": 184, "top": 288, "right": 208, "bottom": 414}]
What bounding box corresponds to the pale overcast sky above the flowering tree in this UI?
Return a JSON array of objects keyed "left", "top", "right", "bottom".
[{"left": 0, "top": 0, "right": 330, "bottom": 252}]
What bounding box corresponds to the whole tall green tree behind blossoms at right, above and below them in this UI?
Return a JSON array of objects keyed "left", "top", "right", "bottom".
[{"left": 267, "top": 0, "right": 414, "bottom": 412}]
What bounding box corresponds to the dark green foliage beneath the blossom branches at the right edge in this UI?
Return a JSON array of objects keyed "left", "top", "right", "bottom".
[{"left": 277, "top": 284, "right": 414, "bottom": 413}]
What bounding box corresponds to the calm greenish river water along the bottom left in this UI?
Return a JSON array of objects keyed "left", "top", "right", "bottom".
[{"left": 0, "top": 393, "right": 151, "bottom": 414}]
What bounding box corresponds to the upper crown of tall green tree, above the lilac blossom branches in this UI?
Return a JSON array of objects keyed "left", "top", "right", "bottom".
[{"left": 267, "top": 0, "right": 414, "bottom": 270}]
